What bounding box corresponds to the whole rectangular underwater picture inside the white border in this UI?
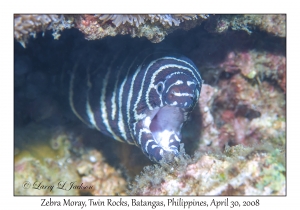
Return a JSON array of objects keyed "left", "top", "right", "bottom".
[{"left": 14, "top": 14, "right": 286, "bottom": 196}]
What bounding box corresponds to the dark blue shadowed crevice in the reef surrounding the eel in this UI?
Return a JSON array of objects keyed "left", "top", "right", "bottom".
[{"left": 14, "top": 22, "right": 285, "bottom": 175}]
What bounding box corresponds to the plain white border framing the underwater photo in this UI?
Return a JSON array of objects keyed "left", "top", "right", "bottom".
[{"left": 0, "top": 0, "right": 300, "bottom": 209}]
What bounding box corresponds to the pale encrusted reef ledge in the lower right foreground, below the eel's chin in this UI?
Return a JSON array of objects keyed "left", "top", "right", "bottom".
[{"left": 128, "top": 145, "right": 286, "bottom": 196}]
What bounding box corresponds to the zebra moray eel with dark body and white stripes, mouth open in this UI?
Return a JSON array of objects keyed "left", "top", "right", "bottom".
[{"left": 69, "top": 46, "right": 202, "bottom": 162}]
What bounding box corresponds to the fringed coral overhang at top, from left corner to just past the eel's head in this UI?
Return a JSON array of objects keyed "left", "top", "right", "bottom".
[{"left": 14, "top": 14, "right": 208, "bottom": 47}]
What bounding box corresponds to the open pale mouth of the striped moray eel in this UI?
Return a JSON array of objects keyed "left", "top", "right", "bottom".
[{"left": 148, "top": 105, "right": 185, "bottom": 154}]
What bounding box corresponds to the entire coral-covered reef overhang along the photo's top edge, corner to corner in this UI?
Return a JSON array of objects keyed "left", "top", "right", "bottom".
[{"left": 14, "top": 14, "right": 286, "bottom": 47}]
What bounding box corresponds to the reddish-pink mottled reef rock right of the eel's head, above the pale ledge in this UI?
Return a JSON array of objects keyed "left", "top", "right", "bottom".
[{"left": 199, "top": 51, "right": 286, "bottom": 151}]
